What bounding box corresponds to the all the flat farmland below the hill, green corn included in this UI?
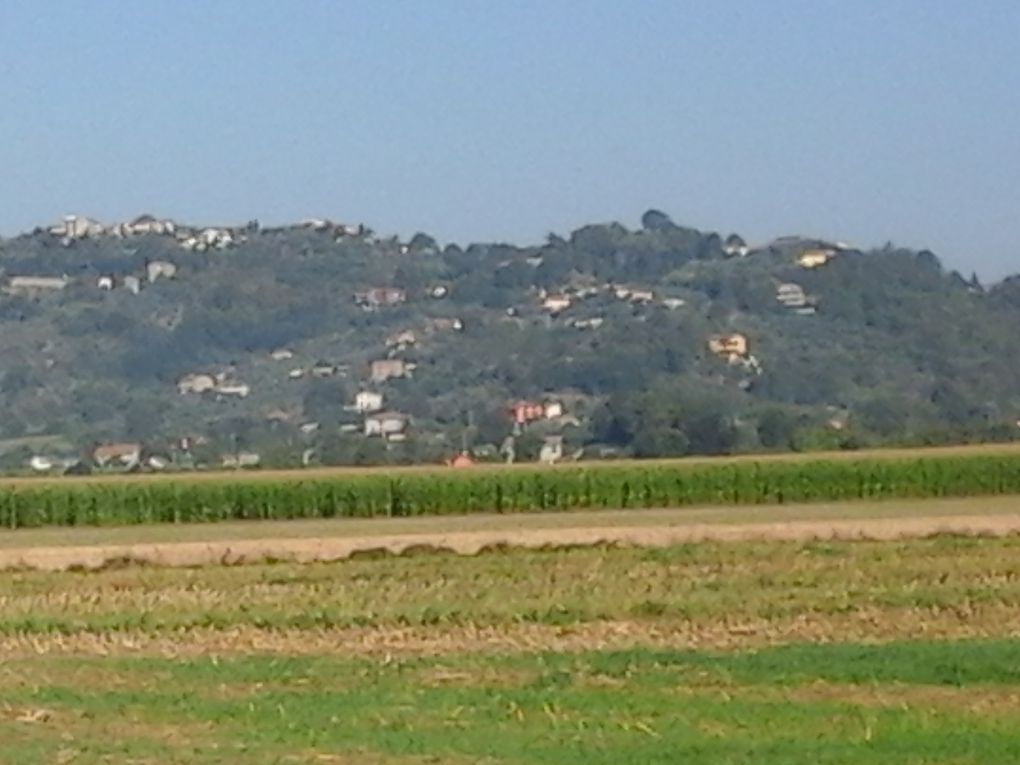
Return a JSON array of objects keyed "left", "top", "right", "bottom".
[{"left": 0, "top": 449, "right": 1020, "bottom": 765}]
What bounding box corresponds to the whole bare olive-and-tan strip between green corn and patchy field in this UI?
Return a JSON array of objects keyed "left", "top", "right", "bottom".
[{"left": 0, "top": 498, "right": 1020, "bottom": 571}]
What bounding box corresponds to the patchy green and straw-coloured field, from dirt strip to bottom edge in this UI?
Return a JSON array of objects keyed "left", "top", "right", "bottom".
[{"left": 0, "top": 536, "right": 1020, "bottom": 765}]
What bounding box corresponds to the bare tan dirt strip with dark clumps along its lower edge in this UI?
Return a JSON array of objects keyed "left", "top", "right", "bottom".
[{"left": 0, "top": 513, "right": 1020, "bottom": 571}]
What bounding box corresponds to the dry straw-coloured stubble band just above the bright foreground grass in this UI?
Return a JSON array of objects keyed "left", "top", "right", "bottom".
[{"left": 0, "top": 606, "right": 1020, "bottom": 660}]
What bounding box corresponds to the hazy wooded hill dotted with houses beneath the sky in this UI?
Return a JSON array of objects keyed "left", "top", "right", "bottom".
[{"left": 0, "top": 211, "right": 1020, "bottom": 469}]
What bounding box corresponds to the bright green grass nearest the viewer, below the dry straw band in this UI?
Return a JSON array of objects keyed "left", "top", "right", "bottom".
[{"left": 0, "top": 641, "right": 1020, "bottom": 765}]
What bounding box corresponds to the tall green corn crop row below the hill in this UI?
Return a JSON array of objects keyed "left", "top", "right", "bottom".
[{"left": 0, "top": 456, "right": 1020, "bottom": 528}]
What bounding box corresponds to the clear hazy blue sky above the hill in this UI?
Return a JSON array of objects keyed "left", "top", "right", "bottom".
[{"left": 0, "top": 0, "right": 1020, "bottom": 277}]
